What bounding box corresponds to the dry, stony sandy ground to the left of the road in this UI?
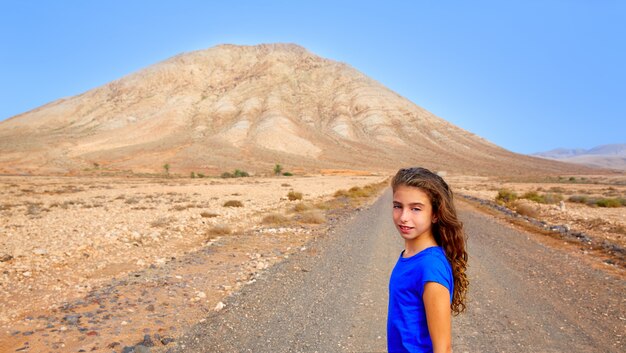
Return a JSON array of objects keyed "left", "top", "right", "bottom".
[{"left": 0, "top": 175, "right": 386, "bottom": 351}]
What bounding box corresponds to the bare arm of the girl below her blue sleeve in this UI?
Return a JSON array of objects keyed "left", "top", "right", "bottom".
[{"left": 422, "top": 282, "right": 452, "bottom": 353}]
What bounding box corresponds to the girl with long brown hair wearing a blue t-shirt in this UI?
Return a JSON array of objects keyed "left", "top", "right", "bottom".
[{"left": 387, "top": 168, "right": 468, "bottom": 353}]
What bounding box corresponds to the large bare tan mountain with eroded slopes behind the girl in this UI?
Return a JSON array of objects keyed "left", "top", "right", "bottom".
[{"left": 0, "top": 44, "right": 585, "bottom": 175}]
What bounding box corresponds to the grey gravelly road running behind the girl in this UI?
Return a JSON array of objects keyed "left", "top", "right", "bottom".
[{"left": 167, "top": 192, "right": 626, "bottom": 353}]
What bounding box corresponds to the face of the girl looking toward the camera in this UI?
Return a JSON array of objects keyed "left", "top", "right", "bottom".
[{"left": 393, "top": 185, "right": 437, "bottom": 240}]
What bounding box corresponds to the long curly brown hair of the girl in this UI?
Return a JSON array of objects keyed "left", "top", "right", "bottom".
[{"left": 391, "top": 168, "right": 469, "bottom": 315}]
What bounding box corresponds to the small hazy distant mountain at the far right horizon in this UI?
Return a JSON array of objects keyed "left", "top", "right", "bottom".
[{"left": 533, "top": 143, "right": 626, "bottom": 170}]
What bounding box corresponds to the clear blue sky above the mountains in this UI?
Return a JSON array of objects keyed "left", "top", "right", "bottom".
[{"left": 0, "top": 0, "right": 626, "bottom": 153}]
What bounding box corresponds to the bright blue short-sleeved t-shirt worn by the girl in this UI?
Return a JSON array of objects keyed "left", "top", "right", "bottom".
[{"left": 387, "top": 246, "right": 454, "bottom": 353}]
